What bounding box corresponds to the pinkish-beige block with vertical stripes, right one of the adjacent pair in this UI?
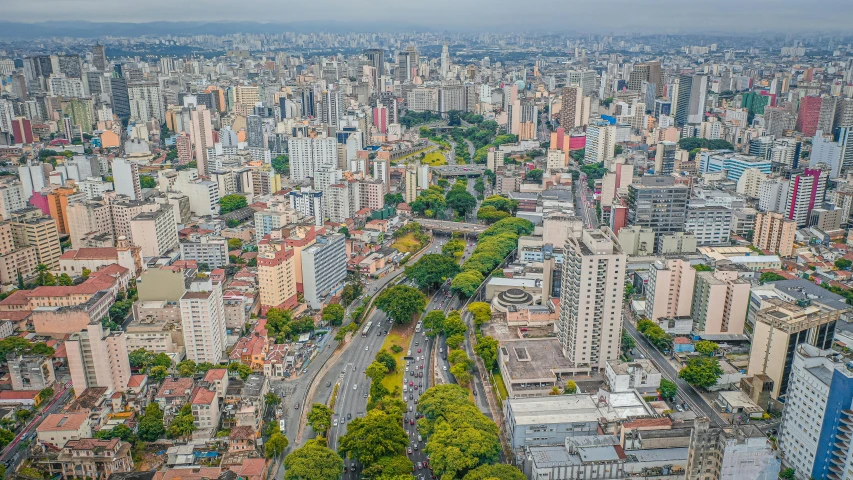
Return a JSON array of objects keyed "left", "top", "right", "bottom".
[{"left": 691, "top": 270, "right": 750, "bottom": 334}]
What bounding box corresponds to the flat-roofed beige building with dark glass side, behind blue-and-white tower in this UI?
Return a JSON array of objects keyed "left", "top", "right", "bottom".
[{"left": 747, "top": 298, "right": 842, "bottom": 401}]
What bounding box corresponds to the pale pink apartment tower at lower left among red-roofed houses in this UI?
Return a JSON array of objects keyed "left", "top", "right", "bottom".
[{"left": 65, "top": 320, "right": 130, "bottom": 397}]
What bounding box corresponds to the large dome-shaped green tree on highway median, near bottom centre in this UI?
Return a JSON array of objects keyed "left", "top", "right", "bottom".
[{"left": 338, "top": 410, "right": 409, "bottom": 465}]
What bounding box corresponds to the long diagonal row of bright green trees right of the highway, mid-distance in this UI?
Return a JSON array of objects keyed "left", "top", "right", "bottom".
[{"left": 450, "top": 217, "right": 533, "bottom": 297}]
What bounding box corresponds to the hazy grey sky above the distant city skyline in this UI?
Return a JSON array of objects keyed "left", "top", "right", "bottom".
[{"left": 5, "top": 0, "right": 853, "bottom": 34}]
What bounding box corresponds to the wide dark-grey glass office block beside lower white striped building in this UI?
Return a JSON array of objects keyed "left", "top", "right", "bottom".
[{"left": 628, "top": 176, "right": 690, "bottom": 240}]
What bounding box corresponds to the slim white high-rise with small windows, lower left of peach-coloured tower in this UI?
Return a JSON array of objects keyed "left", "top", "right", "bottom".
[{"left": 181, "top": 280, "right": 226, "bottom": 365}]
